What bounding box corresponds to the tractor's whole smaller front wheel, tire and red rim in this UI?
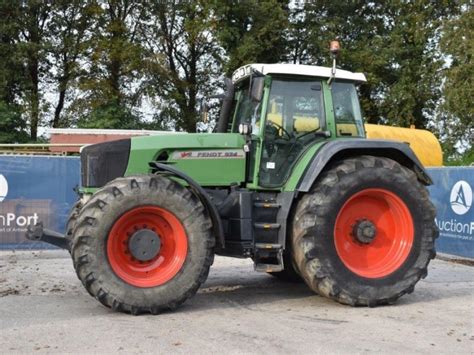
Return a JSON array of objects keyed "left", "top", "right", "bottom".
[{"left": 72, "top": 176, "right": 214, "bottom": 314}]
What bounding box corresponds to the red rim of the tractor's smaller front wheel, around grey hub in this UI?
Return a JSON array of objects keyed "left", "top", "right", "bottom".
[{"left": 107, "top": 206, "right": 188, "bottom": 287}]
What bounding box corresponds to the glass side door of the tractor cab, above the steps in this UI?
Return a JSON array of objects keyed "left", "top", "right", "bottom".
[{"left": 258, "top": 76, "right": 328, "bottom": 188}]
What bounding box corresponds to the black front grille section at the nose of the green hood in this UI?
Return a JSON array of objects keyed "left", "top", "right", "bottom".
[{"left": 81, "top": 139, "right": 130, "bottom": 187}]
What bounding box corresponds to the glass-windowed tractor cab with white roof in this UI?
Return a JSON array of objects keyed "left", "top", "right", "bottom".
[{"left": 217, "top": 64, "right": 365, "bottom": 187}]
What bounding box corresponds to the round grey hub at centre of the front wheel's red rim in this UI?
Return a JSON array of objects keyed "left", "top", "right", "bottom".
[{"left": 128, "top": 228, "right": 161, "bottom": 261}]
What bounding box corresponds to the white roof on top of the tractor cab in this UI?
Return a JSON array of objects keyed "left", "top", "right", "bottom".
[{"left": 232, "top": 64, "right": 367, "bottom": 83}]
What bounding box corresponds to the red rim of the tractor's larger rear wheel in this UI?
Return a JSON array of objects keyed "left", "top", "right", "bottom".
[{"left": 334, "top": 189, "right": 414, "bottom": 278}]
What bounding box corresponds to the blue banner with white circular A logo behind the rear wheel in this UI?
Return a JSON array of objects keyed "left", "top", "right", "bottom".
[{"left": 428, "top": 167, "right": 474, "bottom": 259}]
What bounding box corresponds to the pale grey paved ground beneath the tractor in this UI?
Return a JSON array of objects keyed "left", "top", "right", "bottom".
[{"left": 0, "top": 251, "right": 474, "bottom": 354}]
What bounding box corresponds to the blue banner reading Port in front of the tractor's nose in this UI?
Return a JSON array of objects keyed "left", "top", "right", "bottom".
[{"left": 0, "top": 155, "right": 80, "bottom": 249}]
